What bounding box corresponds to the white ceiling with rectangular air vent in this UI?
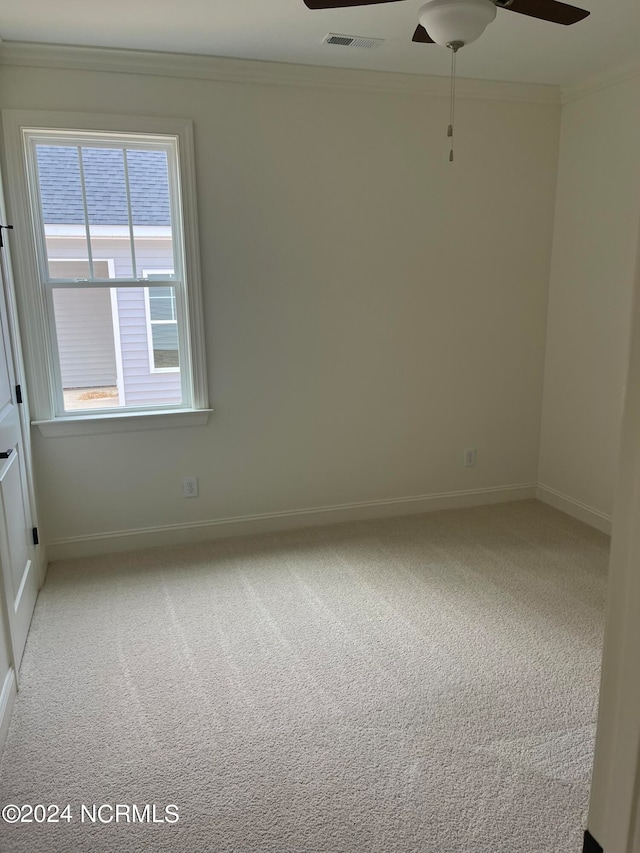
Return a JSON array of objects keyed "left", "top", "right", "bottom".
[{"left": 0, "top": 0, "right": 640, "bottom": 85}]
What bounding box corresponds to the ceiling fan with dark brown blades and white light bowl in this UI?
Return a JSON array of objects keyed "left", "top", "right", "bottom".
[{"left": 304, "top": 0, "right": 589, "bottom": 52}]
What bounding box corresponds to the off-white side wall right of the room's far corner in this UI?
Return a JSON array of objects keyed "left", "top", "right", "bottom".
[{"left": 539, "top": 76, "right": 640, "bottom": 516}]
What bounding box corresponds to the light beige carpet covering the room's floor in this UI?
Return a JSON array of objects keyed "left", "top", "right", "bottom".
[{"left": 0, "top": 501, "right": 608, "bottom": 853}]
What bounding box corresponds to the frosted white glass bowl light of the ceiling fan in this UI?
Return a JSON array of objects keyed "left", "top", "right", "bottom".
[{"left": 418, "top": 0, "right": 497, "bottom": 47}]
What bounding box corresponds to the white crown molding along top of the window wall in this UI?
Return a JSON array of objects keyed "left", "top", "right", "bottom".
[{"left": 0, "top": 41, "right": 560, "bottom": 104}]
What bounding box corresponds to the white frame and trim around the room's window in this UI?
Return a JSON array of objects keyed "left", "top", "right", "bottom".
[{"left": 2, "top": 110, "right": 211, "bottom": 437}]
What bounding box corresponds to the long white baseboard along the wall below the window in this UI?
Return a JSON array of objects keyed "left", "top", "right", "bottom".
[{"left": 47, "top": 483, "right": 536, "bottom": 560}]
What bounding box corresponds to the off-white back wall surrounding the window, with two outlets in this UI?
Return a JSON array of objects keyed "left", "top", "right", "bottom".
[{"left": 0, "top": 51, "right": 560, "bottom": 542}]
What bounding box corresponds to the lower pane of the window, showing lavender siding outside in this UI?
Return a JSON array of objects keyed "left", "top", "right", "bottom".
[{"left": 53, "top": 287, "right": 182, "bottom": 412}]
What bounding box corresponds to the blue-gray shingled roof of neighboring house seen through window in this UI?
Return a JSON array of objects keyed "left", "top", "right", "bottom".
[{"left": 37, "top": 145, "right": 171, "bottom": 225}]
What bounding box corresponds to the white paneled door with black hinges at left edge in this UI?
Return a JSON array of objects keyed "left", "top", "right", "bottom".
[{"left": 0, "top": 232, "right": 39, "bottom": 671}]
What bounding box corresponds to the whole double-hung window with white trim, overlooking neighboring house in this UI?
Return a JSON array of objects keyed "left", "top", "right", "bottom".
[{"left": 3, "top": 110, "right": 208, "bottom": 432}]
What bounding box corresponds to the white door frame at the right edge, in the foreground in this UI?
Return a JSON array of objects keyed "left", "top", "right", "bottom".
[{"left": 585, "top": 210, "right": 640, "bottom": 853}]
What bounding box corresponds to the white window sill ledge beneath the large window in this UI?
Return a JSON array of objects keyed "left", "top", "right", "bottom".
[{"left": 31, "top": 409, "right": 213, "bottom": 438}]
